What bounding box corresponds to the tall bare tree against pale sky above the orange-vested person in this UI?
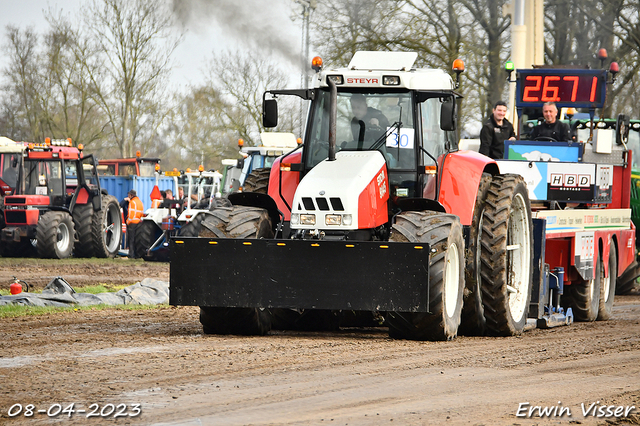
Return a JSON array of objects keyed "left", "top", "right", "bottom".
[{"left": 84, "top": 0, "right": 181, "bottom": 157}]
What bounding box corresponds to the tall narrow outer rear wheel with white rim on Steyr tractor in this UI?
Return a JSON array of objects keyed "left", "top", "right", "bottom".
[{"left": 481, "top": 175, "right": 533, "bottom": 336}]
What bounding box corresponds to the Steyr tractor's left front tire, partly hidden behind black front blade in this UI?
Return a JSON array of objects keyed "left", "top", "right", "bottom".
[{"left": 200, "top": 206, "right": 273, "bottom": 335}]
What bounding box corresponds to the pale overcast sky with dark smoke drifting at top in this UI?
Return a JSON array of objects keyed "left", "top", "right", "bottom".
[{"left": 0, "top": 0, "right": 302, "bottom": 86}]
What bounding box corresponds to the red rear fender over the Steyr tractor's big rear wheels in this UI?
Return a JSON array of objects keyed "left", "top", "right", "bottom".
[{"left": 438, "top": 151, "right": 498, "bottom": 226}]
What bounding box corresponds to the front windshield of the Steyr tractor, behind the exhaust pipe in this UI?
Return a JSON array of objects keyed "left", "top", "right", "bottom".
[{"left": 306, "top": 91, "right": 416, "bottom": 170}]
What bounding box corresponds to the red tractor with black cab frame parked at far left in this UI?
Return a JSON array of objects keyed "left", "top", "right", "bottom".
[{"left": 0, "top": 138, "right": 122, "bottom": 259}]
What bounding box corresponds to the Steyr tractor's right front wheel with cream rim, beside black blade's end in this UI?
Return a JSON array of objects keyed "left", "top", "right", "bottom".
[{"left": 386, "top": 212, "right": 464, "bottom": 340}]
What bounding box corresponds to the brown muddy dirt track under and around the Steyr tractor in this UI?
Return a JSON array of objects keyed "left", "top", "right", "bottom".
[{"left": 0, "top": 259, "right": 640, "bottom": 425}]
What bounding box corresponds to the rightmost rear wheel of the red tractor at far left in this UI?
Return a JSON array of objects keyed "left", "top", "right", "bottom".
[{"left": 91, "top": 195, "right": 122, "bottom": 258}]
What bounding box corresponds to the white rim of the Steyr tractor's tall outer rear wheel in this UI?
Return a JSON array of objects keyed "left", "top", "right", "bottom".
[{"left": 507, "top": 194, "right": 531, "bottom": 321}]
